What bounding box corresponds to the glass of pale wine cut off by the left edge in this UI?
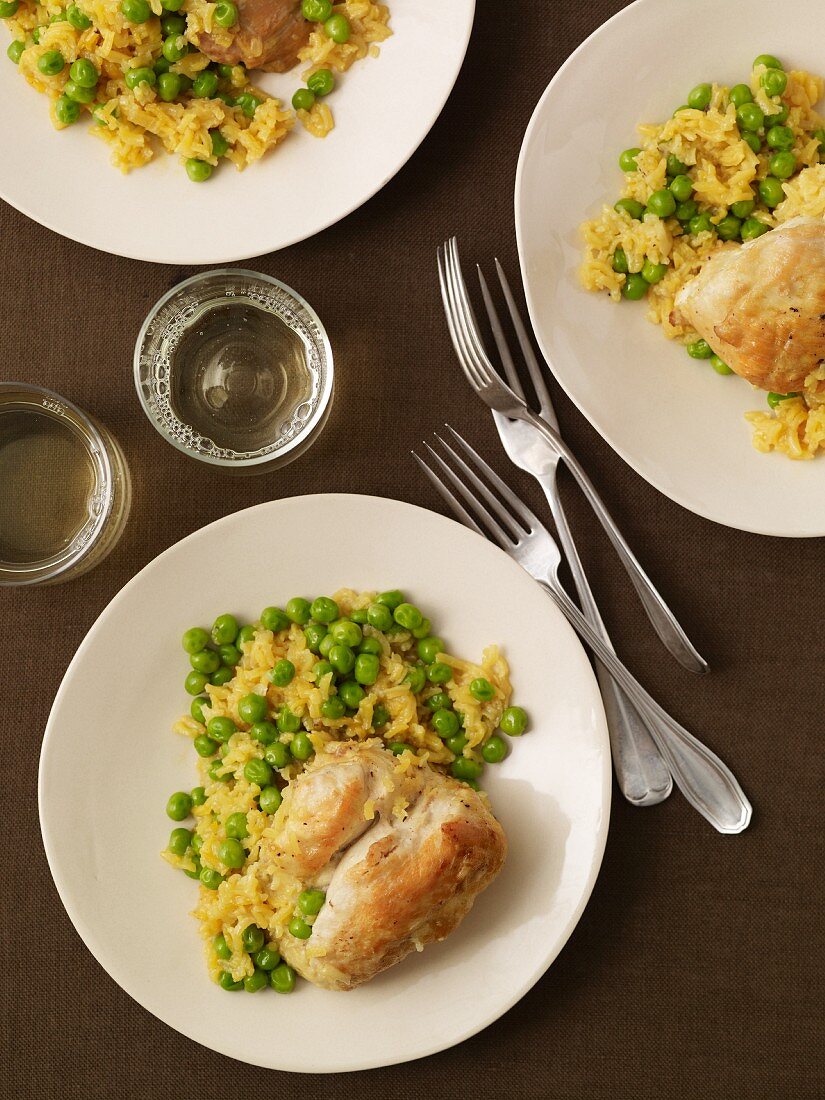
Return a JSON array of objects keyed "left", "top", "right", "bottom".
[{"left": 0, "top": 382, "right": 132, "bottom": 585}]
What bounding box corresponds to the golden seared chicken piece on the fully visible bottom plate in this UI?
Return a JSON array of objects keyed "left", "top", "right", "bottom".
[{"left": 261, "top": 740, "right": 507, "bottom": 989}]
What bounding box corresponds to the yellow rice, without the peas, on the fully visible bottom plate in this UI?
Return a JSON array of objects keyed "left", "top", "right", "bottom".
[{"left": 162, "top": 589, "right": 512, "bottom": 994}]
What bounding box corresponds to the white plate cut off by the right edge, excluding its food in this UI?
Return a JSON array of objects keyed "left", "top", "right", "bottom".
[{"left": 516, "top": 0, "right": 825, "bottom": 536}]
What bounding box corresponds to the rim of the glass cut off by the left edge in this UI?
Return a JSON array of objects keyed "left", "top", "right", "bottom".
[{"left": 0, "top": 382, "right": 114, "bottom": 587}]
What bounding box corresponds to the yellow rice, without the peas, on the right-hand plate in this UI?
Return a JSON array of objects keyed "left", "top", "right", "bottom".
[{"left": 580, "top": 65, "right": 825, "bottom": 459}]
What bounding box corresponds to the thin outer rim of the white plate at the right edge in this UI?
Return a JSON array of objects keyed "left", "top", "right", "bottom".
[{"left": 514, "top": 0, "right": 825, "bottom": 539}]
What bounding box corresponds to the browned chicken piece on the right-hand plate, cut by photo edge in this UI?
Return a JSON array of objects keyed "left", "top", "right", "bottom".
[{"left": 672, "top": 218, "right": 825, "bottom": 394}]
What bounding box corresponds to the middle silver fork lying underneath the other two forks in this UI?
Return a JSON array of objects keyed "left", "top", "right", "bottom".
[{"left": 476, "top": 260, "right": 673, "bottom": 806}]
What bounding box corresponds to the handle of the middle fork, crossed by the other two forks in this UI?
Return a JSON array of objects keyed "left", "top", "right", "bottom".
[{"left": 538, "top": 476, "right": 673, "bottom": 806}]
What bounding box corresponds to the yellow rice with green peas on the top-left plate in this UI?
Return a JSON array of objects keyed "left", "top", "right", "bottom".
[{"left": 0, "top": 0, "right": 392, "bottom": 183}]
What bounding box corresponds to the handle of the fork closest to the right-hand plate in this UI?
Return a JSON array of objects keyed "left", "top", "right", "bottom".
[{"left": 523, "top": 406, "right": 707, "bottom": 673}]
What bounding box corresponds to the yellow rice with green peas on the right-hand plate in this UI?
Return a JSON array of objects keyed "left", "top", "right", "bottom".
[{"left": 580, "top": 54, "right": 825, "bottom": 459}]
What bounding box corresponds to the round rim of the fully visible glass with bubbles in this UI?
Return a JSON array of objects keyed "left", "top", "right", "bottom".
[{"left": 132, "top": 267, "right": 334, "bottom": 470}]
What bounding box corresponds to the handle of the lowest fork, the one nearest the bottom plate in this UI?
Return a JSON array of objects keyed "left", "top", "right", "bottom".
[{"left": 543, "top": 578, "right": 752, "bottom": 833}]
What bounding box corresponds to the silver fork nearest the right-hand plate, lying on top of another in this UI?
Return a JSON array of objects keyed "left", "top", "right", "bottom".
[{"left": 438, "top": 237, "right": 707, "bottom": 672}]
